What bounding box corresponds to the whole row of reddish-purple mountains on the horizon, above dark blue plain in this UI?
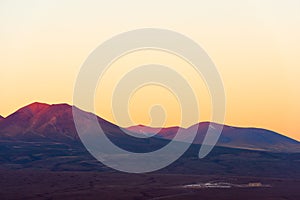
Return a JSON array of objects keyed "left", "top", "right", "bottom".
[{"left": 0, "top": 103, "right": 300, "bottom": 152}]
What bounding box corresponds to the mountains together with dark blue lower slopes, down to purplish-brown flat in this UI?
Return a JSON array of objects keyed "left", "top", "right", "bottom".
[{"left": 0, "top": 103, "right": 300, "bottom": 178}]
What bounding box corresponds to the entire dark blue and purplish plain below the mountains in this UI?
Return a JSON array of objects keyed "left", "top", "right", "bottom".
[{"left": 0, "top": 141, "right": 300, "bottom": 200}]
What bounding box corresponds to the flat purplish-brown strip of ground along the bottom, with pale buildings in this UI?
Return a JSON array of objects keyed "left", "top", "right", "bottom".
[{"left": 0, "top": 170, "right": 300, "bottom": 200}]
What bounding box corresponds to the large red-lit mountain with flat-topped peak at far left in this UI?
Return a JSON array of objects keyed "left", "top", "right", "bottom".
[{"left": 0, "top": 103, "right": 116, "bottom": 140}]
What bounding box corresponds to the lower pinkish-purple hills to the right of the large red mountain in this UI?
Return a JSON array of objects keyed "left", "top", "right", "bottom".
[{"left": 127, "top": 122, "right": 300, "bottom": 152}]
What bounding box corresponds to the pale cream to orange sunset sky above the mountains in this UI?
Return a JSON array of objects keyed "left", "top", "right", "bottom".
[{"left": 0, "top": 0, "right": 300, "bottom": 141}]
